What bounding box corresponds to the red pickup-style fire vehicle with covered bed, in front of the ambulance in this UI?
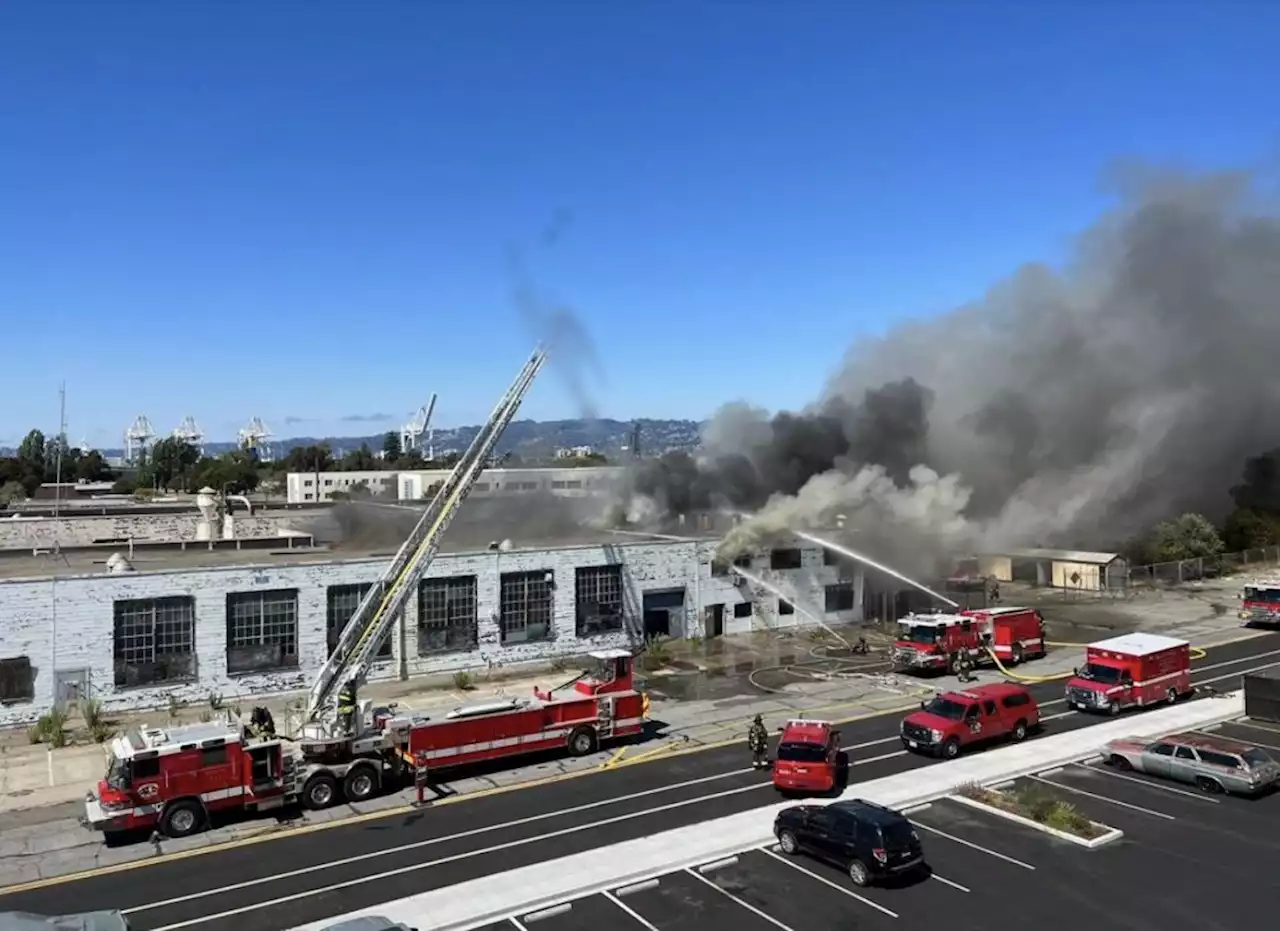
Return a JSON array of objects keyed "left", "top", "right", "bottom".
[{"left": 901, "top": 683, "right": 1039, "bottom": 759}]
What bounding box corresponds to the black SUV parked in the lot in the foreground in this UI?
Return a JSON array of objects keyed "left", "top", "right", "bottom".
[{"left": 773, "top": 799, "right": 924, "bottom": 886}]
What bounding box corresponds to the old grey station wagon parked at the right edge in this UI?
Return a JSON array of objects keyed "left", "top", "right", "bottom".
[{"left": 1102, "top": 733, "right": 1280, "bottom": 795}]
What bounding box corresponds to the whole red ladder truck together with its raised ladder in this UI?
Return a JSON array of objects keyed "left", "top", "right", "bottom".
[{"left": 83, "top": 347, "right": 648, "bottom": 839}]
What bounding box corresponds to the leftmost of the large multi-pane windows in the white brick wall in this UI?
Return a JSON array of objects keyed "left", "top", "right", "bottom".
[{"left": 113, "top": 595, "right": 196, "bottom": 688}]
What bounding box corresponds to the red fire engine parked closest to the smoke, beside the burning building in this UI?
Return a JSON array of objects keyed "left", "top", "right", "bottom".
[{"left": 890, "top": 607, "right": 1047, "bottom": 672}]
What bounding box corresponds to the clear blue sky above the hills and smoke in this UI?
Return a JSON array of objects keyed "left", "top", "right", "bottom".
[{"left": 0, "top": 0, "right": 1280, "bottom": 444}]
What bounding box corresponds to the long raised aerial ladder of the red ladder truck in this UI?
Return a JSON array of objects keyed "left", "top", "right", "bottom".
[{"left": 306, "top": 347, "right": 547, "bottom": 721}]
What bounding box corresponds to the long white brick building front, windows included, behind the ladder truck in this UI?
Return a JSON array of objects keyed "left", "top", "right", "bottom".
[{"left": 0, "top": 535, "right": 861, "bottom": 725}]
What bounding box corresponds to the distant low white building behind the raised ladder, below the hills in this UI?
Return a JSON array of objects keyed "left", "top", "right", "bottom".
[{"left": 285, "top": 466, "right": 626, "bottom": 505}]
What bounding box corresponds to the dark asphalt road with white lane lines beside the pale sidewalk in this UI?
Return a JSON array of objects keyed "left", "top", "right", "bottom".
[{"left": 0, "top": 634, "right": 1280, "bottom": 931}]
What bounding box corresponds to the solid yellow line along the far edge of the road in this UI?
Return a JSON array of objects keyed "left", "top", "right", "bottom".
[{"left": 0, "top": 634, "right": 1280, "bottom": 898}]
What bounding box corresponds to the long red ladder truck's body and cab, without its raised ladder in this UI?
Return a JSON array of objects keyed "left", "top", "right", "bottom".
[{"left": 84, "top": 649, "right": 648, "bottom": 838}]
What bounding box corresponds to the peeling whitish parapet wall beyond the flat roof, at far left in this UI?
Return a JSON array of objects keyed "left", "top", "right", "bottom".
[{"left": 0, "top": 507, "right": 307, "bottom": 549}]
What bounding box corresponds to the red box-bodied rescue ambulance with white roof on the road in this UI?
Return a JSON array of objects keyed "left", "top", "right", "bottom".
[{"left": 1066, "top": 633, "right": 1193, "bottom": 715}]
